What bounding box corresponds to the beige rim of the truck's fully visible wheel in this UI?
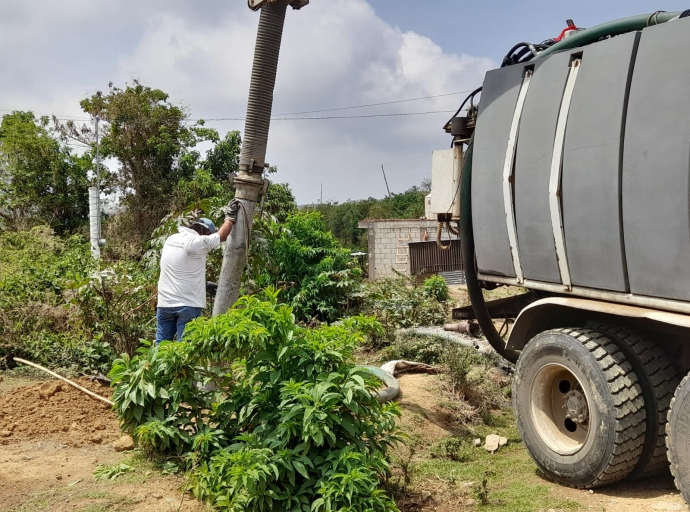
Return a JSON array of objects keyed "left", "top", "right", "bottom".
[{"left": 530, "top": 363, "right": 590, "bottom": 455}]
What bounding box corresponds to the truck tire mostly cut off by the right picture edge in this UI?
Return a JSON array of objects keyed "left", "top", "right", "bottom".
[{"left": 666, "top": 374, "right": 690, "bottom": 503}]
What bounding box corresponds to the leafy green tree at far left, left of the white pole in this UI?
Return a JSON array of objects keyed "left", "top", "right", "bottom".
[{"left": 0, "top": 111, "right": 90, "bottom": 234}]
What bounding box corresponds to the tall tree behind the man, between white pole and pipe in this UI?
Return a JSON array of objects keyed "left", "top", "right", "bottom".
[{"left": 81, "top": 80, "right": 218, "bottom": 247}]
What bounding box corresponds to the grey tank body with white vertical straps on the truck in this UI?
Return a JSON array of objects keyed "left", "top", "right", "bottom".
[{"left": 472, "top": 20, "right": 690, "bottom": 306}]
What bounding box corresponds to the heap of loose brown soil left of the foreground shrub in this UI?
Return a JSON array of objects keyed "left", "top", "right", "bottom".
[{"left": 0, "top": 377, "right": 120, "bottom": 447}]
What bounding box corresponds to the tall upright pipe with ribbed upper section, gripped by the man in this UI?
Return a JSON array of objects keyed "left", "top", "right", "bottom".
[{"left": 213, "top": 0, "right": 288, "bottom": 316}]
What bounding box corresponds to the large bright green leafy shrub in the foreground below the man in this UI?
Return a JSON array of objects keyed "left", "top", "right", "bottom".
[{"left": 110, "top": 290, "right": 399, "bottom": 511}]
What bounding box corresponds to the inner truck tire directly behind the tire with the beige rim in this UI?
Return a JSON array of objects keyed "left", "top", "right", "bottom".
[{"left": 587, "top": 323, "right": 679, "bottom": 478}]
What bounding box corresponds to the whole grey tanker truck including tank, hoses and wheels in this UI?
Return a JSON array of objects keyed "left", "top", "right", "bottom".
[{"left": 446, "top": 11, "right": 690, "bottom": 501}]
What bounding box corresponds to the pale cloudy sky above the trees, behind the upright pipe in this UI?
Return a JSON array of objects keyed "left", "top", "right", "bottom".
[{"left": 0, "top": 0, "right": 496, "bottom": 202}]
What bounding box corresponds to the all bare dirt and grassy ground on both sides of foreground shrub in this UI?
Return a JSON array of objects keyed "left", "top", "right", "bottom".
[{"left": 0, "top": 373, "right": 688, "bottom": 512}]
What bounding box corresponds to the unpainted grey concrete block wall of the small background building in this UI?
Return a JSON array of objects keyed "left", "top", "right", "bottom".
[{"left": 359, "top": 219, "right": 448, "bottom": 280}]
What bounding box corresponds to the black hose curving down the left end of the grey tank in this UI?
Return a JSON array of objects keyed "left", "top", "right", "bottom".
[{"left": 460, "top": 136, "right": 519, "bottom": 363}]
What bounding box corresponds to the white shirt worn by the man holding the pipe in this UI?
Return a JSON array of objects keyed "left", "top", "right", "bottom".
[{"left": 158, "top": 227, "right": 220, "bottom": 308}]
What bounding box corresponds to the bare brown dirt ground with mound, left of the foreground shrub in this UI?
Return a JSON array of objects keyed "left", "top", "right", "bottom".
[{"left": 0, "top": 373, "right": 205, "bottom": 512}]
